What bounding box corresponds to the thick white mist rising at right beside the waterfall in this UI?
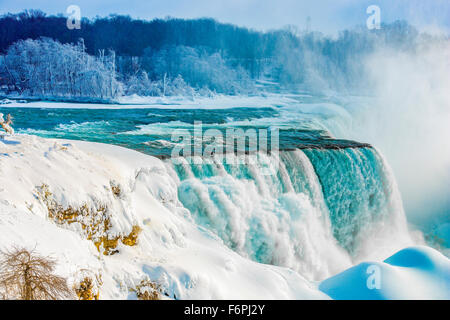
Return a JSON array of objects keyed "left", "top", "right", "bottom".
[{"left": 353, "top": 39, "right": 450, "bottom": 227}]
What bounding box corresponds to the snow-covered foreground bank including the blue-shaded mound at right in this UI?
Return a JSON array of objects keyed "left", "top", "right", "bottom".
[{"left": 0, "top": 135, "right": 450, "bottom": 299}]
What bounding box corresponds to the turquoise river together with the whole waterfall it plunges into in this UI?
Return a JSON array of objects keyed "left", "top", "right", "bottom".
[{"left": 5, "top": 103, "right": 412, "bottom": 280}]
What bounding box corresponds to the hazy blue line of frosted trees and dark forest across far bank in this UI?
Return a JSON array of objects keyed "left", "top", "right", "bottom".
[{"left": 0, "top": 10, "right": 432, "bottom": 99}]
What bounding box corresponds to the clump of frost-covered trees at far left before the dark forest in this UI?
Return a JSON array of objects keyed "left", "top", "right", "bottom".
[{"left": 4, "top": 38, "right": 121, "bottom": 99}]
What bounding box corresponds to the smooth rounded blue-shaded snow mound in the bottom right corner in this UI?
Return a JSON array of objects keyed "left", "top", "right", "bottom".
[{"left": 319, "top": 246, "right": 450, "bottom": 300}]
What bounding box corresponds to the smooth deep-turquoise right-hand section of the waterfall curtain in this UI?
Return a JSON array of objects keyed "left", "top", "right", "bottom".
[{"left": 304, "top": 148, "right": 403, "bottom": 255}]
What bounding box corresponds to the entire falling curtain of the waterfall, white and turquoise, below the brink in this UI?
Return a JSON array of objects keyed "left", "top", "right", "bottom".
[{"left": 166, "top": 148, "right": 407, "bottom": 280}]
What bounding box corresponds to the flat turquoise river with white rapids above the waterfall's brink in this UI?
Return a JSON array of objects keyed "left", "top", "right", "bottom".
[{"left": 0, "top": 108, "right": 370, "bottom": 157}]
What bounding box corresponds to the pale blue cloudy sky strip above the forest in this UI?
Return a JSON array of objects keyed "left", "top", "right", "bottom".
[{"left": 0, "top": 0, "right": 450, "bottom": 34}]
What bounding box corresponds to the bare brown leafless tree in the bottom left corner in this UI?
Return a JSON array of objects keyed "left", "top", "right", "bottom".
[{"left": 0, "top": 248, "right": 74, "bottom": 300}]
